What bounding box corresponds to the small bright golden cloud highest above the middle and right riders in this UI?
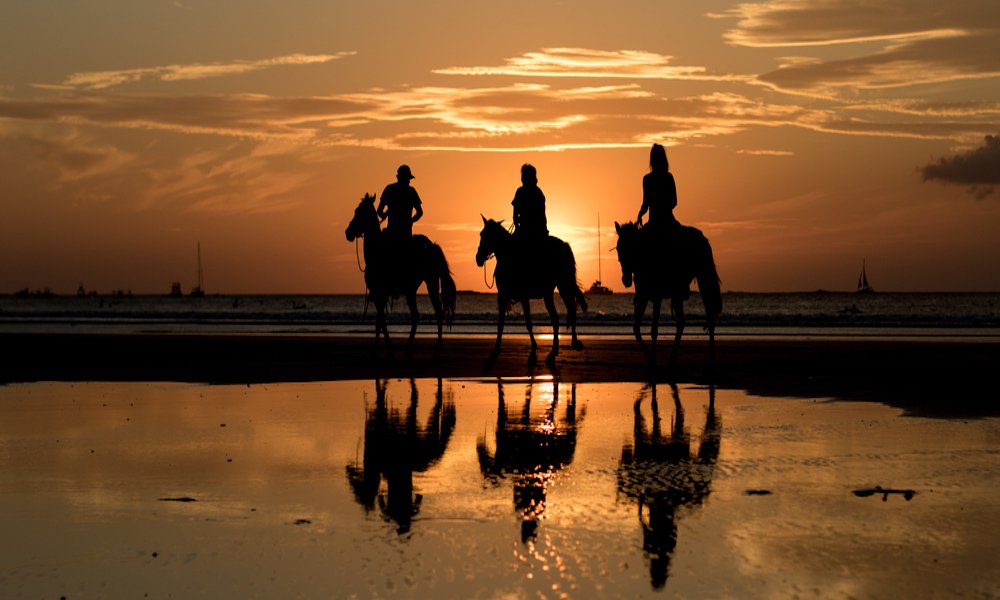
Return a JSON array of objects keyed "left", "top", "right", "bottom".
[{"left": 434, "top": 48, "right": 741, "bottom": 81}]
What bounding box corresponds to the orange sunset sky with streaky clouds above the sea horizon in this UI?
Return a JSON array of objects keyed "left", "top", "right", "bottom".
[{"left": 0, "top": 0, "right": 1000, "bottom": 293}]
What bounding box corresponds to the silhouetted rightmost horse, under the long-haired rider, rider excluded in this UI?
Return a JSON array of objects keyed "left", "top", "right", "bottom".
[{"left": 615, "top": 223, "right": 722, "bottom": 364}]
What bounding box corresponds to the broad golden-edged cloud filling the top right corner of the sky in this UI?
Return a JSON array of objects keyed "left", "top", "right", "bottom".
[{"left": 713, "top": 0, "right": 1000, "bottom": 98}]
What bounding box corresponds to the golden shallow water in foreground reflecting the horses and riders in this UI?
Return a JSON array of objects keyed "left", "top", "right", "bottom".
[{"left": 0, "top": 379, "right": 1000, "bottom": 599}]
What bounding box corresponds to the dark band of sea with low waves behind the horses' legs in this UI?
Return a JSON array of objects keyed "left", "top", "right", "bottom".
[{"left": 0, "top": 292, "right": 1000, "bottom": 337}]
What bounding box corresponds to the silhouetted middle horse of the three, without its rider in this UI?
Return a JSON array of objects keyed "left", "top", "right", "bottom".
[{"left": 476, "top": 217, "right": 587, "bottom": 365}]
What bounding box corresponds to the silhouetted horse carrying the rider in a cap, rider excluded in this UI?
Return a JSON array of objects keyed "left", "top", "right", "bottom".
[{"left": 344, "top": 194, "right": 456, "bottom": 351}]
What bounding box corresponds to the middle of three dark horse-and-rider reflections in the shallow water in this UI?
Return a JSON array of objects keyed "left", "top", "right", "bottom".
[{"left": 476, "top": 382, "right": 583, "bottom": 543}]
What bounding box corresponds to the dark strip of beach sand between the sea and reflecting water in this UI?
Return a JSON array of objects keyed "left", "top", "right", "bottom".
[{"left": 0, "top": 334, "right": 1000, "bottom": 417}]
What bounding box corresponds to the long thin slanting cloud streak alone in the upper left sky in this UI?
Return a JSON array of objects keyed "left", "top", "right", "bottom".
[{"left": 63, "top": 51, "right": 355, "bottom": 90}]
